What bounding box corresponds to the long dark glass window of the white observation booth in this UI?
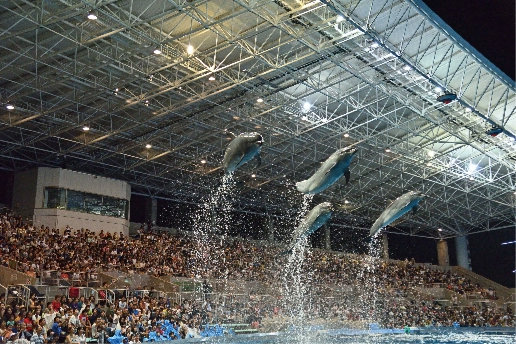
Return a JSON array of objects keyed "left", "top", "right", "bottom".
[{"left": 43, "top": 187, "right": 129, "bottom": 219}]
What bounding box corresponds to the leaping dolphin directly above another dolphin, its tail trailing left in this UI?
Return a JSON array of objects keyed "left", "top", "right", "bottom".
[{"left": 296, "top": 147, "right": 357, "bottom": 194}]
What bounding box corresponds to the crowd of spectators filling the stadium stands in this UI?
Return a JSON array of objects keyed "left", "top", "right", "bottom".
[{"left": 0, "top": 210, "right": 516, "bottom": 344}]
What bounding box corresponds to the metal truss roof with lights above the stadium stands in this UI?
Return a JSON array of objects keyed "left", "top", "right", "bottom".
[{"left": 0, "top": 0, "right": 516, "bottom": 238}]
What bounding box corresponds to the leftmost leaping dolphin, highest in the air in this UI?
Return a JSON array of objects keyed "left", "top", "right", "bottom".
[{"left": 222, "top": 131, "right": 264, "bottom": 174}]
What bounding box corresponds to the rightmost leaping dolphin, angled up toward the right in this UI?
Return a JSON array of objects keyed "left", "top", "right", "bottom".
[{"left": 369, "top": 191, "right": 426, "bottom": 236}]
